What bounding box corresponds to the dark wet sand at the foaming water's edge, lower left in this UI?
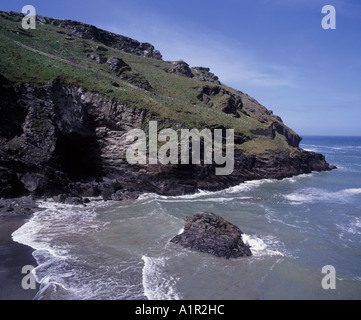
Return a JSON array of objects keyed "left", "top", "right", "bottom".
[{"left": 0, "top": 215, "right": 38, "bottom": 300}]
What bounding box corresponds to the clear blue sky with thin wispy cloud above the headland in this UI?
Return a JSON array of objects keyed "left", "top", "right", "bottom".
[{"left": 0, "top": 0, "right": 361, "bottom": 136}]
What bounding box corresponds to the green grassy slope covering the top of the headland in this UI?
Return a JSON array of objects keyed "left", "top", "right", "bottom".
[{"left": 0, "top": 13, "right": 289, "bottom": 154}]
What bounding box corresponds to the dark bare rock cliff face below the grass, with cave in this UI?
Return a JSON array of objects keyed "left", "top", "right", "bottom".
[{"left": 0, "top": 77, "right": 331, "bottom": 200}]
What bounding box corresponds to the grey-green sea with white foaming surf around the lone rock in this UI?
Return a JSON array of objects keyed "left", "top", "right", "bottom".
[{"left": 13, "top": 137, "right": 361, "bottom": 300}]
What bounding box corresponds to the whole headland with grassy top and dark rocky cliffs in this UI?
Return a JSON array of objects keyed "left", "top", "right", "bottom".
[{"left": 0, "top": 13, "right": 334, "bottom": 200}]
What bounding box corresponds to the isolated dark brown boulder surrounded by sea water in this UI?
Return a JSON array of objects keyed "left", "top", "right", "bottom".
[{"left": 171, "top": 212, "right": 252, "bottom": 259}]
